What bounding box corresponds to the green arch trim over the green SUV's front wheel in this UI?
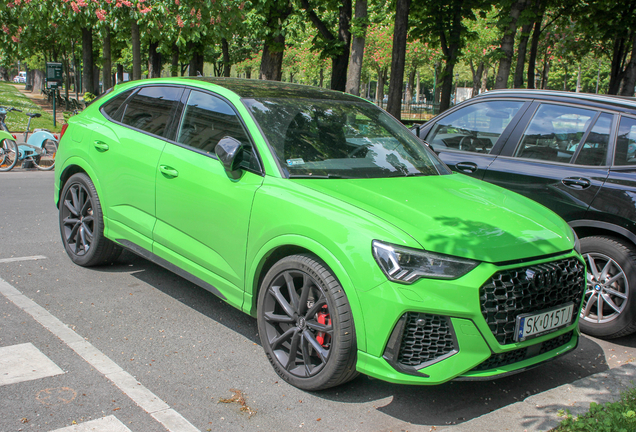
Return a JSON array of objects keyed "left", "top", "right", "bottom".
[{"left": 243, "top": 235, "right": 366, "bottom": 350}]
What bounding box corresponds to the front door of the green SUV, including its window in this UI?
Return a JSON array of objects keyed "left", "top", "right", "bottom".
[{"left": 153, "top": 90, "right": 263, "bottom": 307}]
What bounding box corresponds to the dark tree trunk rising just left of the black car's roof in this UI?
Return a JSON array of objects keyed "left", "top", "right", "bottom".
[{"left": 386, "top": 0, "right": 411, "bottom": 120}]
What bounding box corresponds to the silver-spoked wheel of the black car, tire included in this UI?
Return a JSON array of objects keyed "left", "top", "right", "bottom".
[{"left": 579, "top": 236, "right": 636, "bottom": 339}]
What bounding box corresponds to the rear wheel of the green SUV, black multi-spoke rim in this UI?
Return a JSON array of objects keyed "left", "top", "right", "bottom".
[{"left": 59, "top": 173, "right": 122, "bottom": 267}]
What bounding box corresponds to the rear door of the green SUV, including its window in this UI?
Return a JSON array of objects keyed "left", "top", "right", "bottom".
[{"left": 89, "top": 86, "right": 183, "bottom": 251}]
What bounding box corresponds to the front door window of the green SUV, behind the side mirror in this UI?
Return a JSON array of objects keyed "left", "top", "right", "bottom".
[{"left": 177, "top": 90, "right": 250, "bottom": 154}]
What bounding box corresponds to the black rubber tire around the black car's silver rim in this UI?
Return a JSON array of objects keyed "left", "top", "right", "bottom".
[{"left": 579, "top": 237, "right": 636, "bottom": 338}]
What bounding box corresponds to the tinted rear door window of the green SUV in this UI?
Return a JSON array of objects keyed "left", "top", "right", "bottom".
[{"left": 122, "top": 87, "right": 183, "bottom": 137}]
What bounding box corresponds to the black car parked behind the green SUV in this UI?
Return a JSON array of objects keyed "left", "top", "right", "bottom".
[{"left": 412, "top": 90, "right": 636, "bottom": 338}]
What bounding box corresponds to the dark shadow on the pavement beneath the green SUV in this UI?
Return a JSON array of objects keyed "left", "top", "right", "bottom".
[{"left": 93, "top": 251, "right": 612, "bottom": 425}]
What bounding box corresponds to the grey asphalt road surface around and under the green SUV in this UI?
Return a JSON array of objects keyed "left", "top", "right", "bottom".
[{"left": 0, "top": 170, "right": 636, "bottom": 432}]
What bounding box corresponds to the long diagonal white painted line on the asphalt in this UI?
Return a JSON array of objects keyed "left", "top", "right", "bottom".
[{"left": 0, "top": 278, "right": 200, "bottom": 432}]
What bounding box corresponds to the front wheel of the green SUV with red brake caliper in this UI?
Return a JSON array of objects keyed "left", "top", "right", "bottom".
[{"left": 257, "top": 254, "right": 358, "bottom": 391}]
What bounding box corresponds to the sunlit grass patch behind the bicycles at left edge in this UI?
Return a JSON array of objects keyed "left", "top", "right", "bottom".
[{"left": 0, "top": 82, "right": 62, "bottom": 132}]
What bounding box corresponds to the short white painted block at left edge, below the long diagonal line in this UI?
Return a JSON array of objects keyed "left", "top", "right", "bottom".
[{"left": 0, "top": 343, "right": 64, "bottom": 386}]
